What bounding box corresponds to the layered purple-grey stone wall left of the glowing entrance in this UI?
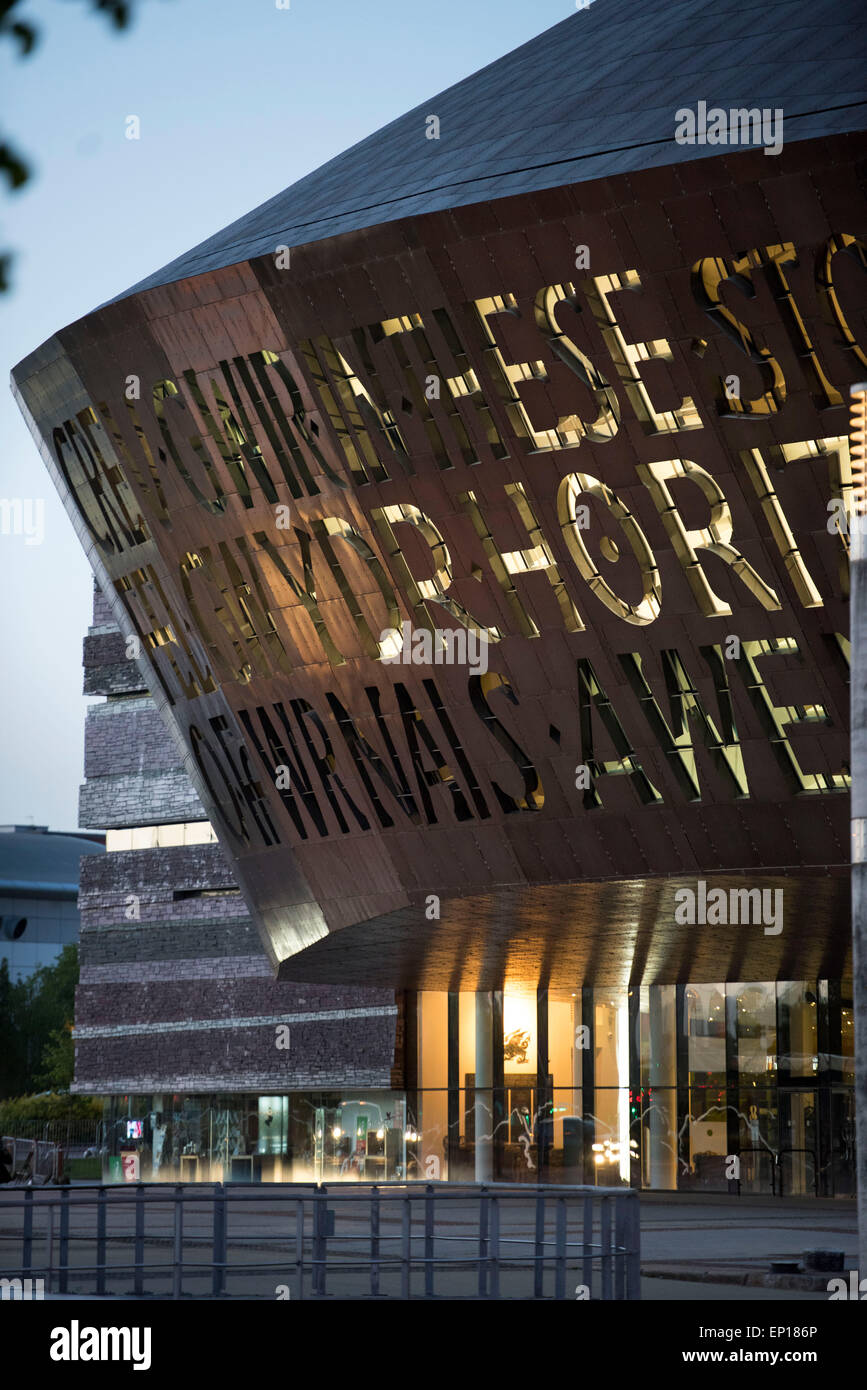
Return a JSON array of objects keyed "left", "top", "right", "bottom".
[{"left": 74, "top": 588, "right": 403, "bottom": 1094}]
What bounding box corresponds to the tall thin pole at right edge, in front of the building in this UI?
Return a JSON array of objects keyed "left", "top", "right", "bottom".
[{"left": 849, "top": 381, "right": 867, "bottom": 1280}]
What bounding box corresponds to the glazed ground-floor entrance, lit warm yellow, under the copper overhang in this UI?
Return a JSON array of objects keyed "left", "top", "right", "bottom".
[{"left": 104, "top": 980, "right": 854, "bottom": 1197}]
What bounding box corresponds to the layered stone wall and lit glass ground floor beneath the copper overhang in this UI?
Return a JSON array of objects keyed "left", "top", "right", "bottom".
[{"left": 75, "top": 589, "right": 854, "bottom": 1195}]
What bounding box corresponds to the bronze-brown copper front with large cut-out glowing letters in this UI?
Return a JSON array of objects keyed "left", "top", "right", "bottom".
[{"left": 18, "top": 138, "right": 866, "bottom": 988}]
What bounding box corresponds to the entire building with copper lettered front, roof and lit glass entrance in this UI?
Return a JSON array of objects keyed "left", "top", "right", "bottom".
[{"left": 15, "top": 0, "right": 867, "bottom": 1193}]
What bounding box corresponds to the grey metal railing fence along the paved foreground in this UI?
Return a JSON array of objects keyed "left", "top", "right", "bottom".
[{"left": 0, "top": 1183, "right": 641, "bottom": 1300}]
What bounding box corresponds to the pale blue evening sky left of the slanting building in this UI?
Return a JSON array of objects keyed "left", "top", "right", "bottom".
[{"left": 0, "top": 0, "right": 578, "bottom": 830}]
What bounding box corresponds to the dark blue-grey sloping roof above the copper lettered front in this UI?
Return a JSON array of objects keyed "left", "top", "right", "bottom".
[{"left": 118, "top": 0, "right": 867, "bottom": 299}]
